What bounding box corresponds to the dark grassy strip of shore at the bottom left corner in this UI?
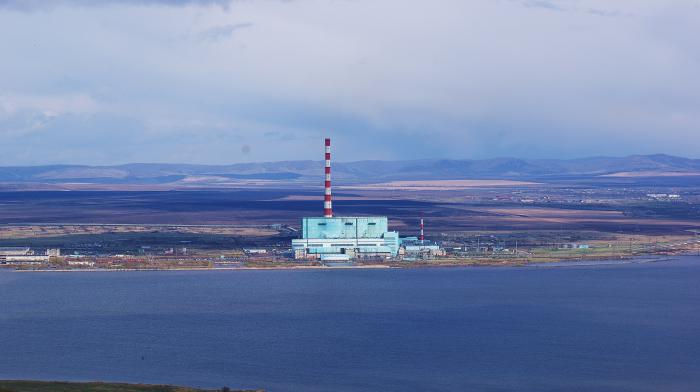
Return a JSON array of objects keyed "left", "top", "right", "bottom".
[{"left": 0, "top": 381, "right": 260, "bottom": 392}]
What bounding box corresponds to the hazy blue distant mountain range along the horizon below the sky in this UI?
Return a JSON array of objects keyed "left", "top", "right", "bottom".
[{"left": 0, "top": 154, "right": 700, "bottom": 184}]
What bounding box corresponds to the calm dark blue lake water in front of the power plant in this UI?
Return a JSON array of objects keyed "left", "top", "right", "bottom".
[{"left": 0, "top": 257, "right": 700, "bottom": 392}]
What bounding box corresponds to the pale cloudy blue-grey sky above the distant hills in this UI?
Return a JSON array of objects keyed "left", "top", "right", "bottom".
[{"left": 0, "top": 0, "right": 700, "bottom": 166}]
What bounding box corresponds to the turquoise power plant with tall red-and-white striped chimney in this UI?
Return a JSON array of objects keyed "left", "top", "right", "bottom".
[{"left": 292, "top": 139, "right": 434, "bottom": 261}]
